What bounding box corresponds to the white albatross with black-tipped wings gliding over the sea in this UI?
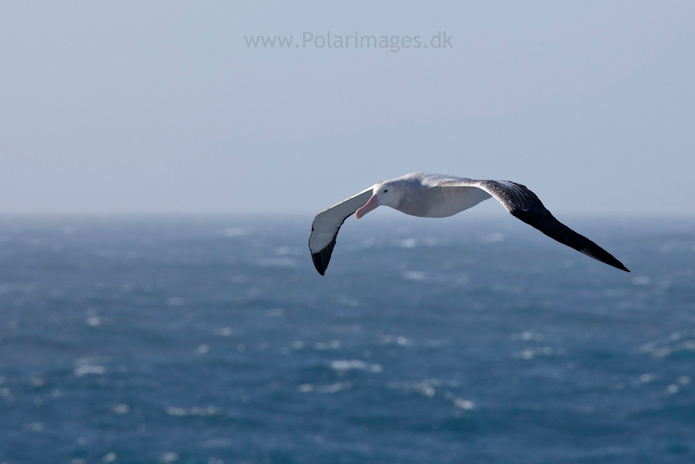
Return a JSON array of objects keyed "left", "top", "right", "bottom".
[{"left": 309, "top": 172, "right": 630, "bottom": 275}]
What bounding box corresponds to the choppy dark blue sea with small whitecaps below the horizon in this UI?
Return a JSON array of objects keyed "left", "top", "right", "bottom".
[{"left": 0, "top": 214, "right": 695, "bottom": 464}]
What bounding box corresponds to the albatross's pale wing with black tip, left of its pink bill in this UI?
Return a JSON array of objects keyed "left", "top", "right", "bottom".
[{"left": 309, "top": 187, "right": 372, "bottom": 275}]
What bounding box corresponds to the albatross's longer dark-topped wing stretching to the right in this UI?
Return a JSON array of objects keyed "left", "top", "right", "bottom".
[{"left": 438, "top": 179, "right": 630, "bottom": 272}]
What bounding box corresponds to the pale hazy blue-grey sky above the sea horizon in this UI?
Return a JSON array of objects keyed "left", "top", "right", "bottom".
[{"left": 0, "top": 0, "right": 695, "bottom": 215}]
